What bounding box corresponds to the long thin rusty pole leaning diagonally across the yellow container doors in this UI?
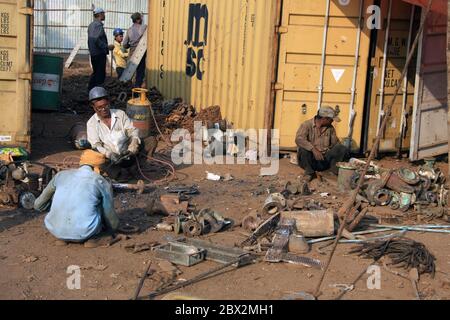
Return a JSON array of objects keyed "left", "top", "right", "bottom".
[{"left": 314, "top": 0, "right": 433, "bottom": 297}]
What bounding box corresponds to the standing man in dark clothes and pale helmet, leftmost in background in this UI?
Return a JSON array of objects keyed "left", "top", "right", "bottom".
[{"left": 88, "top": 8, "right": 109, "bottom": 90}]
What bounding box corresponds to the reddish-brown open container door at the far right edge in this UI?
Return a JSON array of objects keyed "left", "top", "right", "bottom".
[{"left": 410, "top": 8, "right": 448, "bottom": 161}]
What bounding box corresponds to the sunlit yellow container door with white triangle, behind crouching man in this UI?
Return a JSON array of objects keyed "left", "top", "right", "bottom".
[{"left": 274, "top": 0, "right": 373, "bottom": 149}]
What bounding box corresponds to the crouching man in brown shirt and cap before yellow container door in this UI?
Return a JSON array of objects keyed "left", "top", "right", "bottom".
[{"left": 296, "top": 106, "right": 348, "bottom": 182}]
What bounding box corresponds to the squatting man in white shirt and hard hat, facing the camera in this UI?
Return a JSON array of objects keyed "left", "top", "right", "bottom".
[{"left": 87, "top": 87, "right": 157, "bottom": 181}]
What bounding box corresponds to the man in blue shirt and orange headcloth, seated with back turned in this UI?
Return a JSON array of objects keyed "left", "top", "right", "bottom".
[{"left": 34, "top": 150, "right": 119, "bottom": 247}]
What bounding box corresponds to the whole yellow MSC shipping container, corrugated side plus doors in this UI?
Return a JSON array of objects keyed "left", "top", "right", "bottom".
[{"left": 147, "top": 0, "right": 444, "bottom": 158}]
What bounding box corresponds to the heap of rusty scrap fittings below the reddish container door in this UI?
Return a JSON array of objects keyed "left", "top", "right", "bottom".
[{"left": 340, "top": 159, "right": 448, "bottom": 216}]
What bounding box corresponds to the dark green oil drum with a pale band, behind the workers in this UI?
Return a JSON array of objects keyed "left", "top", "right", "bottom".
[{"left": 31, "top": 54, "right": 64, "bottom": 111}]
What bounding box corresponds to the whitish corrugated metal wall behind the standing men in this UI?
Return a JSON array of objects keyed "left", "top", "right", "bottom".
[{"left": 34, "top": 0, "right": 148, "bottom": 53}]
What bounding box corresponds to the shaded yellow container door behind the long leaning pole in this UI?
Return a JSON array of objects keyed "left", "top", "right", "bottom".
[{"left": 365, "top": 0, "right": 417, "bottom": 152}]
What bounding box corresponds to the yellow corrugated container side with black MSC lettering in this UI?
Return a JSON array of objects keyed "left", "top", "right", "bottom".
[{"left": 147, "top": 0, "right": 276, "bottom": 129}]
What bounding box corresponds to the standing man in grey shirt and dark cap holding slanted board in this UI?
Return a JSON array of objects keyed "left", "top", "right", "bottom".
[{"left": 123, "top": 12, "right": 147, "bottom": 88}]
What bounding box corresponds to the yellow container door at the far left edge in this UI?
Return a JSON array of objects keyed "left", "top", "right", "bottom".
[{"left": 0, "top": 0, "right": 33, "bottom": 150}]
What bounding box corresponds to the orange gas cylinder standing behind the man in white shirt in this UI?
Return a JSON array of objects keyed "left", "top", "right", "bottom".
[{"left": 127, "top": 88, "right": 153, "bottom": 139}]
